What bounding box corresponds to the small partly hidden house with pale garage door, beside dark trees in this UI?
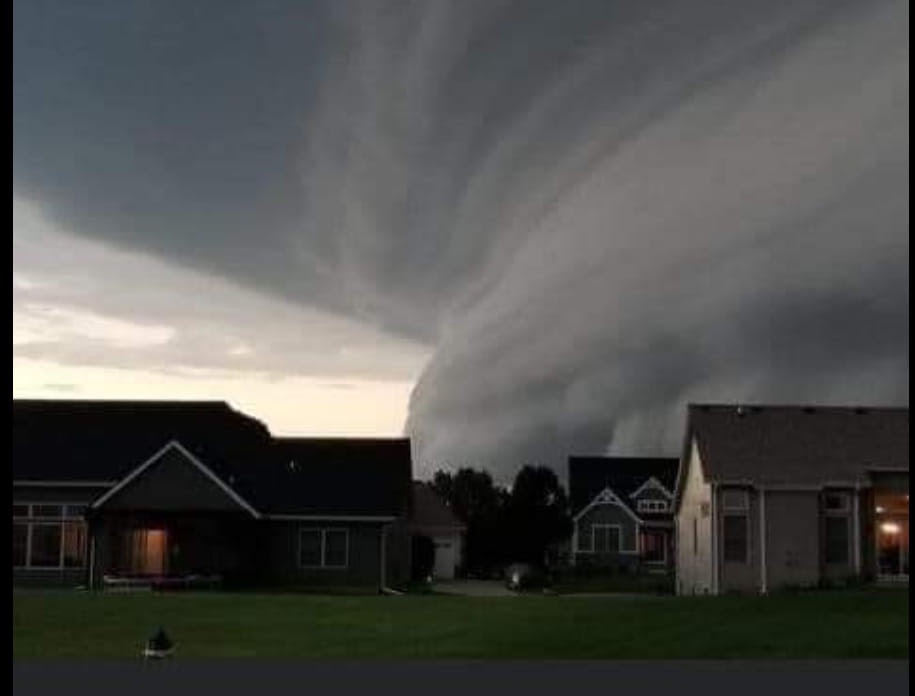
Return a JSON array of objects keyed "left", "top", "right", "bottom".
[{"left": 410, "top": 481, "right": 466, "bottom": 580}]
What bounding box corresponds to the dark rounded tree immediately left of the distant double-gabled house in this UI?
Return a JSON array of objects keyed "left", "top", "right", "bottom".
[{"left": 506, "top": 466, "right": 572, "bottom": 565}]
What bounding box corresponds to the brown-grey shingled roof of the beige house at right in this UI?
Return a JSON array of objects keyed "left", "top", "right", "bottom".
[{"left": 686, "top": 404, "right": 909, "bottom": 485}]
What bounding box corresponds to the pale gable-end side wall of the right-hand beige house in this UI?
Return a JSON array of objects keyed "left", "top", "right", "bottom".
[{"left": 674, "top": 441, "right": 713, "bottom": 594}]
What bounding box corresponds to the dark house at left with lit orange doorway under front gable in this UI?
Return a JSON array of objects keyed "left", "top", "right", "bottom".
[{"left": 13, "top": 399, "right": 412, "bottom": 589}]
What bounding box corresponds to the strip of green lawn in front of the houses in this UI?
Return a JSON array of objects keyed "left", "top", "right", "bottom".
[{"left": 13, "top": 589, "right": 909, "bottom": 659}]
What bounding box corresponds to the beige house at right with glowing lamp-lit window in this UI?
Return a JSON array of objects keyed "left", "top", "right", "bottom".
[{"left": 674, "top": 405, "right": 909, "bottom": 594}]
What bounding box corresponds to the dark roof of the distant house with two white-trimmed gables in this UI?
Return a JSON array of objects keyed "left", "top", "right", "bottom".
[{"left": 569, "top": 457, "right": 679, "bottom": 517}]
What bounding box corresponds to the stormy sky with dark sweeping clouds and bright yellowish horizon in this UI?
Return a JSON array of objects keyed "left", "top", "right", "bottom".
[{"left": 13, "top": 0, "right": 909, "bottom": 480}]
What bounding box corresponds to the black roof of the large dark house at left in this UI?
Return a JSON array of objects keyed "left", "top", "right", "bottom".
[{"left": 12, "top": 399, "right": 412, "bottom": 516}]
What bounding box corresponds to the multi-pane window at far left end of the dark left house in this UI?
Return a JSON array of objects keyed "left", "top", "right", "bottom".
[{"left": 13, "top": 503, "right": 86, "bottom": 569}]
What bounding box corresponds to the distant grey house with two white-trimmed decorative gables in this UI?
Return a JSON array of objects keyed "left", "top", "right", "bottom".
[{"left": 568, "top": 457, "right": 679, "bottom": 571}]
